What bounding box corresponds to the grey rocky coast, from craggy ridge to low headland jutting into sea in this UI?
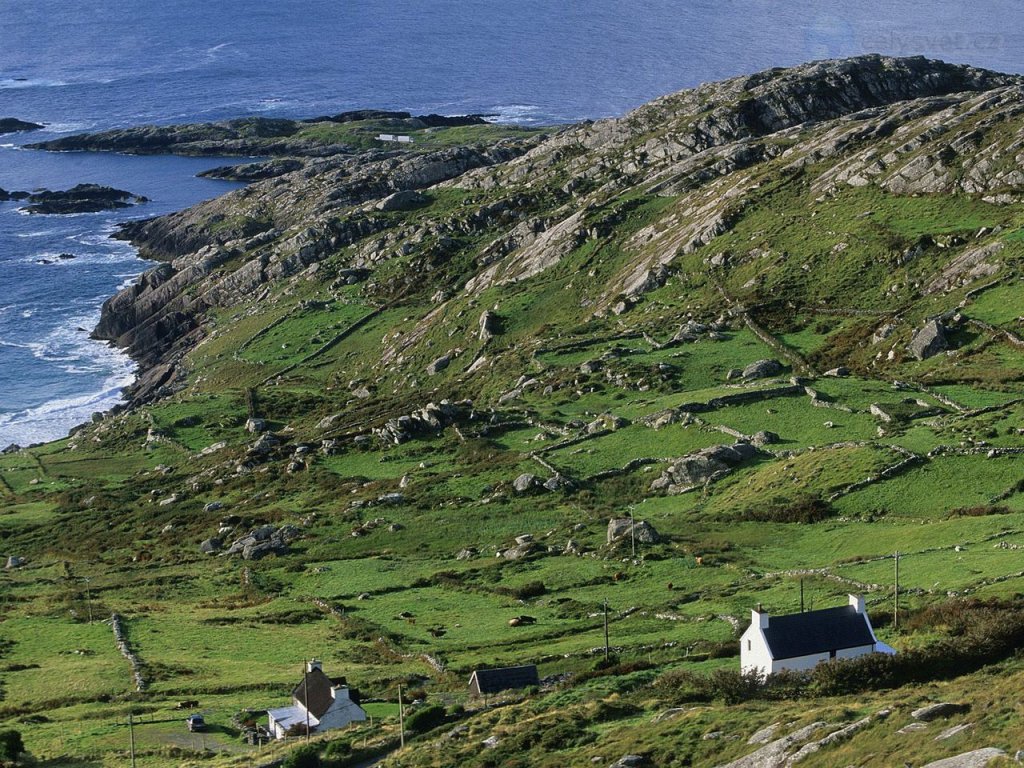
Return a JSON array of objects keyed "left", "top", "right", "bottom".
[{"left": 36, "top": 55, "right": 1024, "bottom": 415}]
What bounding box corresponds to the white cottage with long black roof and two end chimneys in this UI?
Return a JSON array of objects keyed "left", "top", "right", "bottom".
[{"left": 739, "top": 595, "right": 896, "bottom": 676}]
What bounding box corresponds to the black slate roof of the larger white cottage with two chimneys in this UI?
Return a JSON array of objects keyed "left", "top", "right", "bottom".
[{"left": 764, "top": 605, "right": 874, "bottom": 658}]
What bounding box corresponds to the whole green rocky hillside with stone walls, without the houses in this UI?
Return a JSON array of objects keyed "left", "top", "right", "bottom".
[{"left": 0, "top": 56, "right": 1024, "bottom": 768}]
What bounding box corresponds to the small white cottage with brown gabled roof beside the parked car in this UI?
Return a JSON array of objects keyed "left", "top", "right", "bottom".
[{"left": 266, "top": 658, "right": 367, "bottom": 738}]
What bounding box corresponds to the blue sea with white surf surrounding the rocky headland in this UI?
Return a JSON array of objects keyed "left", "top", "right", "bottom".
[{"left": 0, "top": 0, "right": 1024, "bottom": 446}]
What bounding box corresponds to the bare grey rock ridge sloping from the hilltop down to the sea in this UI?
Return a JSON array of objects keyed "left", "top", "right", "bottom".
[{"left": 68, "top": 55, "right": 1024, "bottom": 400}]
